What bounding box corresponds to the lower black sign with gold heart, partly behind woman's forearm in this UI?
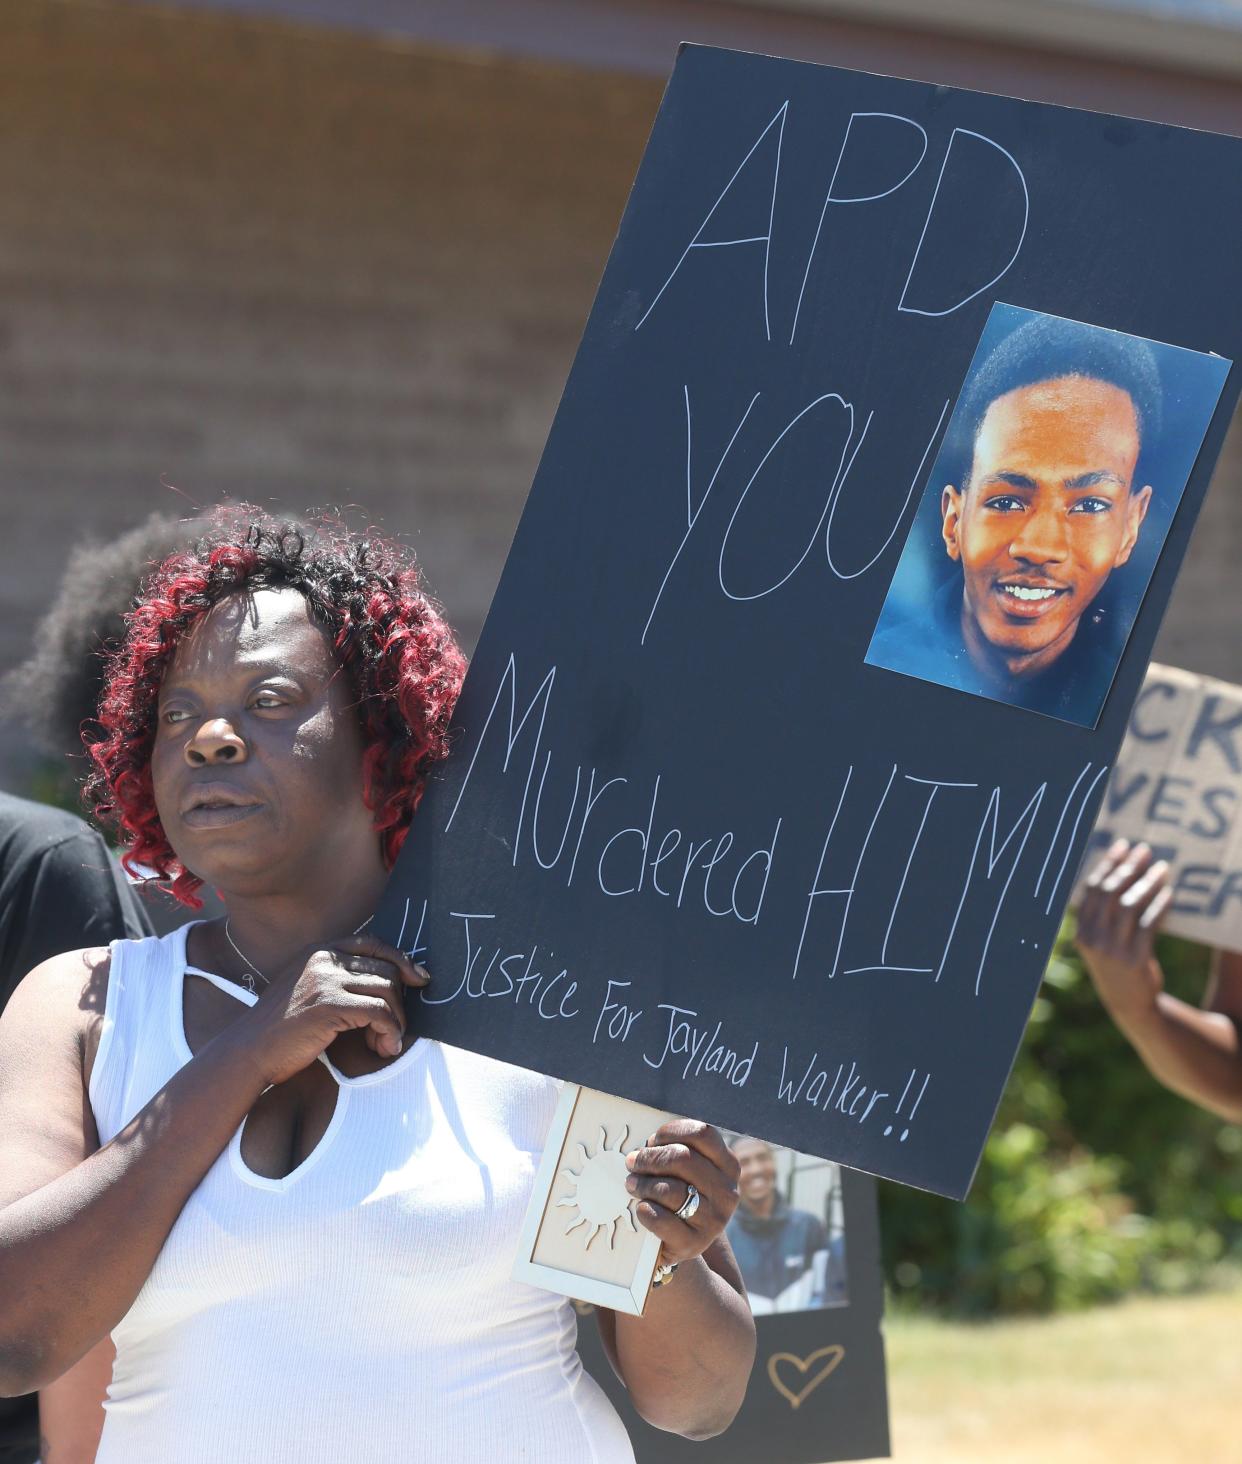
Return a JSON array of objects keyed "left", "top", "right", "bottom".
[{"left": 579, "top": 1140, "right": 889, "bottom": 1464}]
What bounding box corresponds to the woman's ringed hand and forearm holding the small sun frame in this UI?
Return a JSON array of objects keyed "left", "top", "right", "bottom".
[{"left": 599, "top": 1118, "right": 754, "bottom": 1439}]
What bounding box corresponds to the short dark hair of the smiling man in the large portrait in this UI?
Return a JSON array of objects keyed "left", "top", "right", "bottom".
[{"left": 952, "top": 315, "right": 1161, "bottom": 482}]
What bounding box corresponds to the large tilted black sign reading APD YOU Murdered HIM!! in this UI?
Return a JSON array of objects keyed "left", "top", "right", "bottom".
[{"left": 379, "top": 47, "right": 1242, "bottom": 1195}]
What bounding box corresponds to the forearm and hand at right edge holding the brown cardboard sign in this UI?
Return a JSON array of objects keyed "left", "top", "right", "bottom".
[{"left": 1078, "top": 839, "right": 1242, "bottom": 1123}]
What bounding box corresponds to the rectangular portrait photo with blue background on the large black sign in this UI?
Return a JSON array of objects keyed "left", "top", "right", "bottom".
[{"left": 867, "top": 305, "right": 1229, "bottom": 726}]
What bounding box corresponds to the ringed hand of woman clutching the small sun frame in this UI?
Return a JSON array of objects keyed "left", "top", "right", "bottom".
[{"left": 625, "top": 1118, "right": 740, "bottom": 1263}]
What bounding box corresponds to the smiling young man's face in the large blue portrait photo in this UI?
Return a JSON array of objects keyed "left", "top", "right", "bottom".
[{"left": 940, "top": 376, "right": 1151, "bottom": 676}]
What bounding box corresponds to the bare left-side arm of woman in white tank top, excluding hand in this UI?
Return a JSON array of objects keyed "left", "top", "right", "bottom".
[{"left": 0, "top": 952, "right": 267, "bottom": 1395}]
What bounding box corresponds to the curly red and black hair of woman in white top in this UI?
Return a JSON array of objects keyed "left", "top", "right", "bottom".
[{"left": 83, "top": 504, "right": 466, "bottom": 908}]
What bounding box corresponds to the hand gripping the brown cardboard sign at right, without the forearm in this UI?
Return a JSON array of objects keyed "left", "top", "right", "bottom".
[{"left": 1078, "top": 839, "right": 1173, "bottom": 1015}]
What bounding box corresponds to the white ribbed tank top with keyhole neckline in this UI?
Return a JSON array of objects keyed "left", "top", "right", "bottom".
[{"left": 89, "top": 928, "right": 634, "bottom": 1464}]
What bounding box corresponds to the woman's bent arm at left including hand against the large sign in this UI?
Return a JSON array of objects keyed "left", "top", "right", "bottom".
[{"left": 0, "top": 937, "right": 426, "bottom": 1395}]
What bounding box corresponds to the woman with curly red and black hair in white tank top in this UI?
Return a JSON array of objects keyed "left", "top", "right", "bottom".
[{"left": 0, "top": 511, "right": 754, "bottom": 1464}]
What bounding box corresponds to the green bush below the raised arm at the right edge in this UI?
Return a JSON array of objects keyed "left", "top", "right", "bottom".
[{"left": 880, "top": 916, "right": 1242, "bottom": 1316}]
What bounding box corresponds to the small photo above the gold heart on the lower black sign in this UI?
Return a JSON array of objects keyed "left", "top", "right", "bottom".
[{"left": 726, "top": 1133, "right": 849, "bottom": 1316}]
